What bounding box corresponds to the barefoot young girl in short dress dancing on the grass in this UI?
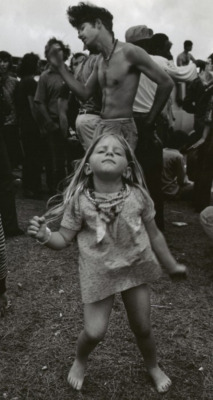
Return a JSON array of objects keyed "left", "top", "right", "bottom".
[{"left": 28, "top": 135, "right": 186, "bottom": 393}]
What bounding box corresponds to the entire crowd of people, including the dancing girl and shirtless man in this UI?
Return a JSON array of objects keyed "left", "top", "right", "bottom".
[{"left": 0, "top": 3, "right": 213, "bottom": 392}]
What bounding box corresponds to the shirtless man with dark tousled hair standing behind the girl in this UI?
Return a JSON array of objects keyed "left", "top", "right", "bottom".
[{"left": 49, "top": 3, "right": 173, "bottom": 149}]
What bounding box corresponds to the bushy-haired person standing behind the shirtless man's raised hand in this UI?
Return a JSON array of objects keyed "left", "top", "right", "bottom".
[{"left": 34, "top": 37, "right": 70, "bottom": 194}]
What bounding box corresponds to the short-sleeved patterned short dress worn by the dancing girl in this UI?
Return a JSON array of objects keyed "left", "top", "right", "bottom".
[{"left": 61, "top": 187, "right": 162, "bottom": 303}]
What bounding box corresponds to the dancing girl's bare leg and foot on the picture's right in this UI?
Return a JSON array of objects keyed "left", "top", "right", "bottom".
[{"left": 122, "top": 285, "right": 171, "bottom": 393}]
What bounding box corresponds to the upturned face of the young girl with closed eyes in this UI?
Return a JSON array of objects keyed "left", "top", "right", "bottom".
[{"left": 87, "top": 136, "right": 128, "bottom": 179}]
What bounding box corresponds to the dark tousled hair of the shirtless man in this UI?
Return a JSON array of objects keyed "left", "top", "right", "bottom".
[{"left": 67, "top": 2, "right": 113, "bottom": 35}]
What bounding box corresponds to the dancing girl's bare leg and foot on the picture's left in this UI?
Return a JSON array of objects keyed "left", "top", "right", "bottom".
[{"left": 68, "top": 296, "right": 114, "bottom": 390}]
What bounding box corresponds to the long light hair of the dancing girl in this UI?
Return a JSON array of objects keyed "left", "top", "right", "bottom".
[{"left": 45, "top": 134, "right": 147, "bottom": 221}]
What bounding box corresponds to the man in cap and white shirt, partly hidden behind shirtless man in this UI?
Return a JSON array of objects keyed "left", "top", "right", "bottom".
[{"left": 126, "top": 25, "right": 197, "bottom": 229}]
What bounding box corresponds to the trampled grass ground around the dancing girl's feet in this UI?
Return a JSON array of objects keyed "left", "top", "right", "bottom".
[{"left": 0, "top": 197, "right": 213, "bottom": 400}]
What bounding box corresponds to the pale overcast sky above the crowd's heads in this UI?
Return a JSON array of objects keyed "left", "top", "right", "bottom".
[{"left": 0, "top": 0, "right": 213, "bottom": 59}]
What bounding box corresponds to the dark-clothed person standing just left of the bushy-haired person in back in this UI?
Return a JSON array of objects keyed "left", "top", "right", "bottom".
[{"left": 18, "top": 53, "right": 42, "bottom": 198}]
